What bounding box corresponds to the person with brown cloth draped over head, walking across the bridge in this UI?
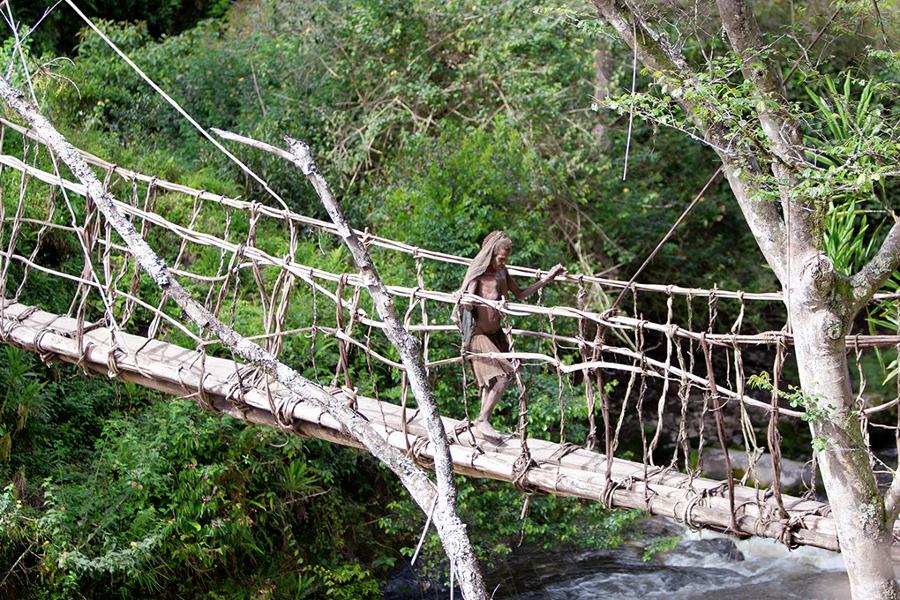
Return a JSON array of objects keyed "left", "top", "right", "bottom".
[{"left": 460, "top": 231, "right": 565, "bottom": 441}]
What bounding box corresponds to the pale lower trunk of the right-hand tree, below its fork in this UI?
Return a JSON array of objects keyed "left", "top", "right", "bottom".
[{"left": 786, "top": 255, "right": 900, "bottom": 600}]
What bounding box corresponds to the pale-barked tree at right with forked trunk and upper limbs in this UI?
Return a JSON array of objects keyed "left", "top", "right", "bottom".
[{"left": 594, "top": 0, "right": 900, "bottom": 599}]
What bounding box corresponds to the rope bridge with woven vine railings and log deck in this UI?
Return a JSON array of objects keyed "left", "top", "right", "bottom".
[{"left": 0, "top": 120, "right": 900, "bottom": 550}]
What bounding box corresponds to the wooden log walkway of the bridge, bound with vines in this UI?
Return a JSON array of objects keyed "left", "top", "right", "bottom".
[{"left": 0, "top": 301, "right": 900, "bottom": 562}]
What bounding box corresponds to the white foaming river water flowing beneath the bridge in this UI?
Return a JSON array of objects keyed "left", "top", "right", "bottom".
[{"left": 385, "top": 521, "right": 850, "bottom": 600}]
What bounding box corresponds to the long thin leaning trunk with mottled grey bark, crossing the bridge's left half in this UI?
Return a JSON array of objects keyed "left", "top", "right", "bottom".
[{"left": 0, "top": 77, "right": 486, "bottom": 599}]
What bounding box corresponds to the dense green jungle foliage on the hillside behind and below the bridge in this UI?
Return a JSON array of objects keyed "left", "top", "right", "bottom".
[{"left": 0, "top": 0, "right": 900, "bottom": 599}]
